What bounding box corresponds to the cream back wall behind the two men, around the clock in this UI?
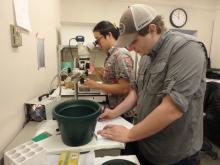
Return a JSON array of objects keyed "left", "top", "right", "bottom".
[{"left": 61, "top": 0, "right": 220, "bottom": 67}]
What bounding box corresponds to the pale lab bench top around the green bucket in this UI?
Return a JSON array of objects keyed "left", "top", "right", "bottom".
[{"left": 5, "top": 117, "right": 139, "bottom": 164}]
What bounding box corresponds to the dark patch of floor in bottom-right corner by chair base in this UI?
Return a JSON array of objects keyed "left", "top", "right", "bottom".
[{"left": 201, "top": 141, "right": 220, "bottom": 165}]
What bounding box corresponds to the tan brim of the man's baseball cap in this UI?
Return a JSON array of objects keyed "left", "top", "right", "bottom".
[{"left": 115, "top": 32, "right": 137, "bottom": 47}]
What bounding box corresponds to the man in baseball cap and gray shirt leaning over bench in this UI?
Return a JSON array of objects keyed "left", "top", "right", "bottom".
[{"left": 98, "top": 4, "right": 207, "bottom": 165}]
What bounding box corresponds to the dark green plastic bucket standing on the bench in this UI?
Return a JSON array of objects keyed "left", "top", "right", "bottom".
[{"left": 53, "top": 100, "right": 101, "bottom": 146}]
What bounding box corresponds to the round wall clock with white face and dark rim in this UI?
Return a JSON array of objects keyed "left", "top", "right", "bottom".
[{"left": 170, "top": 8, "right": 187, "bottom": 28}]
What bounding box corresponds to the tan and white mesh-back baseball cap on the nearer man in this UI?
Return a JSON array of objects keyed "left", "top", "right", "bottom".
[{"left": 116, "top": 4, "right": 157, "bottom": 47}]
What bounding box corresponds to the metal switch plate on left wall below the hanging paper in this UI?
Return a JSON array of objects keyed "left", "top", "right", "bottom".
[{"left": 10, "top": 25, "right": 22, "bottom": 48}]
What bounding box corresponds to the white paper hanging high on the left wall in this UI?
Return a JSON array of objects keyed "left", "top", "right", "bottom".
[{"left": 14, "top": 0, "right": 31, "bottom": 31}]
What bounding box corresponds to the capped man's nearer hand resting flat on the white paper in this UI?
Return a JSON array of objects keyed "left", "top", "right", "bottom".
[{"left": 98, "top": 124, "right": 130, "bottom": 143}]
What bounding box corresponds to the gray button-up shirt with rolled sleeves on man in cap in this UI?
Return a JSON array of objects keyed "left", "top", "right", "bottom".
[{"left": 136, "top": 32, "right": 206, "bottom": 164}]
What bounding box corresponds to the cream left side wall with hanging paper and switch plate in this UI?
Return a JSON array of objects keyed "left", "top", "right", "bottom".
[{"left": 0, "top": 0, "right": 60, "bottom": 158}]
